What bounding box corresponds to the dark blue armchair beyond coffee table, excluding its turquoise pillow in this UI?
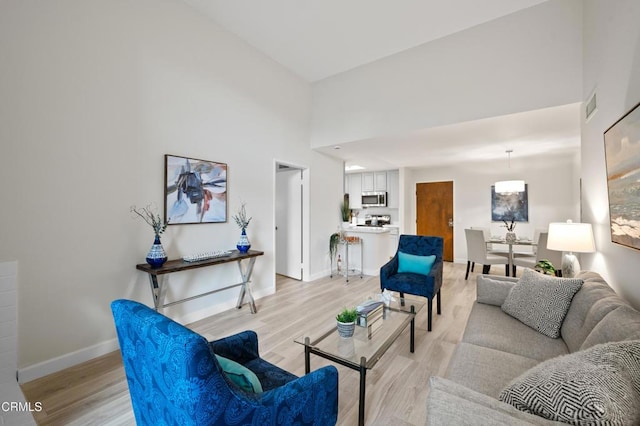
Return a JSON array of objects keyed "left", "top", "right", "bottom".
[{"left": 380, "top": 235, "right": 444, "bottom": 331}]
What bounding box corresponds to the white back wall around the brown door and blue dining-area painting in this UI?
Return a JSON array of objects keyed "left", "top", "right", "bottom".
[{"left": 403, "top": 151, "right": 580, "bottom": 263}]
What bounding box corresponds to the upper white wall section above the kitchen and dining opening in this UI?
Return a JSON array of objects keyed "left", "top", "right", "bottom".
[{"left": 311, "top": 0, "right": 582, "bottom": 147}]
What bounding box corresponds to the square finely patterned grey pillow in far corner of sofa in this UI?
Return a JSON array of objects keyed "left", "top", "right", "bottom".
[{"left": 502, "top": 269, "right": 582, "bottom": 339}]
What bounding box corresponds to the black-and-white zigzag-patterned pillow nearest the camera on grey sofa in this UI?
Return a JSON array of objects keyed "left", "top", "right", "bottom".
[{"left": 499, "top": 340, "right": 640, "bottom": 425}]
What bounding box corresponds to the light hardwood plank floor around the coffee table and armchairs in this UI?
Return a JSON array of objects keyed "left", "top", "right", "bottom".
[{"left": 22, "top": 263, "right": 504, "bottom": 426}]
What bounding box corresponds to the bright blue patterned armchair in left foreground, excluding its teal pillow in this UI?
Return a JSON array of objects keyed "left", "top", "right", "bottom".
[{"left": 111, "top": 300, "right": 338, "bottom": 426}]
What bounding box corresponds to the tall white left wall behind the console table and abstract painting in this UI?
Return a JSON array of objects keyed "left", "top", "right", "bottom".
[{"left": 0, "top": 0, "right": 342, "bottom": 380}]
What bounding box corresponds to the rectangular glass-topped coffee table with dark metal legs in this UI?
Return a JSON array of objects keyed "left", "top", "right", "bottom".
[{"left": 294, "top": 299, "right": 425, "bottom": 425}]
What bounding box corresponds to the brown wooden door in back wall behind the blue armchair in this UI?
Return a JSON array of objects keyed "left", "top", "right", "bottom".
[{"left": 416, "top": 181, "right": 453, "bottom": 262}]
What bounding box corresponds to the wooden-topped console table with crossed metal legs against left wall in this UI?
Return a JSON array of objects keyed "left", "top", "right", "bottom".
[{"left": 136, "top": 250, "right": 264, "bottom": 314}]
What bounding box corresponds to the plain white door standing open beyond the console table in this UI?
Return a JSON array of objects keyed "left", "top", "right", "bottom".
[{"left": 276, "top": 165, "right": 302, "bottom": 280}]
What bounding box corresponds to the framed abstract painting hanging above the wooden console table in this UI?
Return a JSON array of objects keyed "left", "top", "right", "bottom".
[{"left": 164, "top": 155, "right": 227, "bottom": 225}]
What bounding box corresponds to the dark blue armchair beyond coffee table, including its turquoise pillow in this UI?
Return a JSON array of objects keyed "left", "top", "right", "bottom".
[{"left": 380, "top": 235, "right": 444, "bottom": 331}]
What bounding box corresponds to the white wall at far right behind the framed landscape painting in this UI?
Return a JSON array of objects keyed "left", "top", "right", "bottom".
[{"left": 581, "top": 0, "right": 640, "bottom": 308}]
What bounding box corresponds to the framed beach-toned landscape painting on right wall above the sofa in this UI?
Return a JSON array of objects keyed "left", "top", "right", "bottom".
[{"left": 604, "top": 104, "right": 640, "bottom": 249}]
